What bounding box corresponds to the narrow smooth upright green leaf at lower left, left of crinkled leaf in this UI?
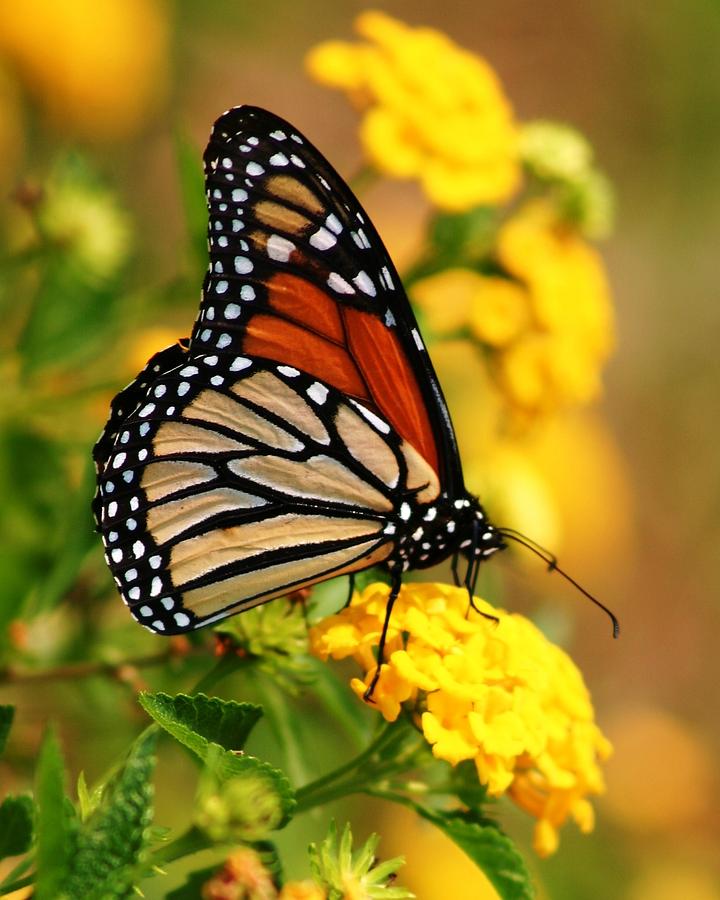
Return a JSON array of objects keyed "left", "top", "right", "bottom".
[{"left": 34, "top": 730, "right": 76, "bottom": 900}]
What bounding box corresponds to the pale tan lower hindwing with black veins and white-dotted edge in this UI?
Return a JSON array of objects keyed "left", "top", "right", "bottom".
[{"left": 95, "top": 348, "right": 440, "bottom": 634}]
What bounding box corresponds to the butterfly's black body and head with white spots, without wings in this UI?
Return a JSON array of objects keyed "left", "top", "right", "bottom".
[{"left": 385, "top": 494, "right": 505, "bottom": 571}]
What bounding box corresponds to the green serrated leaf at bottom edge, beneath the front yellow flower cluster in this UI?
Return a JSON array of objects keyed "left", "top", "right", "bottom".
[{"left": 412, "top": 803, "right": 535, "bottom": 900}]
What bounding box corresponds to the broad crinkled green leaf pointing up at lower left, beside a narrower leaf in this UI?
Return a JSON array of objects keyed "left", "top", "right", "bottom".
[{"left": 65, "top": 729, "right": 157, "bottom": 900}]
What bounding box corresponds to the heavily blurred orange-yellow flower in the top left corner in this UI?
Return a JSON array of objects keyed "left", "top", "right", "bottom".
[{"left": 0, "top": 0, "right": 168, "bottom": 140}]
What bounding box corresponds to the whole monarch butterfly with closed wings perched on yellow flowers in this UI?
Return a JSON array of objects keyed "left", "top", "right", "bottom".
[{"left": 94, "top": 106, "right": 616, "bottom": 668}]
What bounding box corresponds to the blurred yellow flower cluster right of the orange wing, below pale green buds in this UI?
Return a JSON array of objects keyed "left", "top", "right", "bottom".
[{"left": 411, "top": 200, "right": 614, "bottom": 418}]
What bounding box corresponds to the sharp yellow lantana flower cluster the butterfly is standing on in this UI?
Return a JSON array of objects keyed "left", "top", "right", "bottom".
[{"left": 311, "top": 584, "right": 611, "bottom": 856}]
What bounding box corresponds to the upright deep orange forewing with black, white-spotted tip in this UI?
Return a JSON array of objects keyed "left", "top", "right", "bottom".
[{"left": 190, "top": 106, "right": 465, "bottom": 498}]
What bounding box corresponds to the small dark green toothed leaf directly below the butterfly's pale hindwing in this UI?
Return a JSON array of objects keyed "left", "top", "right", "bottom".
[{"left": 139, "top": 692, "right": 262, "bottom": 759}]
